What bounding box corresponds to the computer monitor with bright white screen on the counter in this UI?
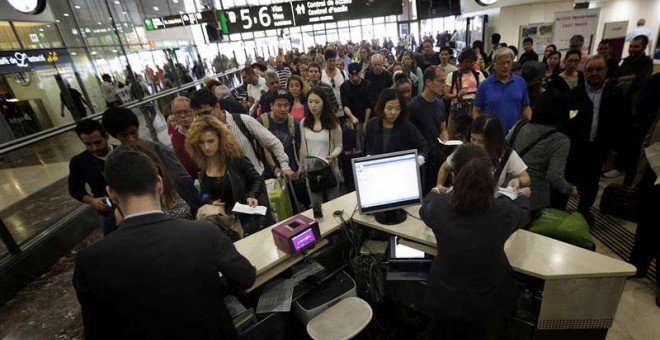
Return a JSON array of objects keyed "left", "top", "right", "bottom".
[{"left": 352, "top": 150, "right": 422, "bottom": 224}]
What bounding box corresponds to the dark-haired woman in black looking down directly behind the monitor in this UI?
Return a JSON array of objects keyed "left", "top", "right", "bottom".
[{"left": 365, "top": 89, "right": 429, "bottom": 159}]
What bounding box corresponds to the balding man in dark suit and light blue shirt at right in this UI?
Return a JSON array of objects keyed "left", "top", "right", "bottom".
[{"left": 566, "top": 55, "right": 630, "bottom": 225}]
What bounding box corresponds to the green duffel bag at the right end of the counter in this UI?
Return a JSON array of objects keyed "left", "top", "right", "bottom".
[{"left": 529, "top": 208, "right": 596, "bottom": 250}]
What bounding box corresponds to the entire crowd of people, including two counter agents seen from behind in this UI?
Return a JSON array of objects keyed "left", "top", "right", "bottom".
[{"left": 69, "top": 27, "right": 660, "bottom": 339}]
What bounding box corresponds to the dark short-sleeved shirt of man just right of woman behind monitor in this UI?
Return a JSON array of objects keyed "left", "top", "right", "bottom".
[{"left": 408, "top": 95, "right": 446, "bottom": 145}]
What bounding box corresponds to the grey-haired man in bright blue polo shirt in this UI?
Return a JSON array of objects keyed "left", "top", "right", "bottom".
[{"left": 472, "top": 47, "right": 532, "bottom": 132}]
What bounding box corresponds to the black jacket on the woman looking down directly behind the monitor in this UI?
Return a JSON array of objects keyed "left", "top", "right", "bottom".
[{"left": 364, "top": 117, "right": 430, "bottom": 160}]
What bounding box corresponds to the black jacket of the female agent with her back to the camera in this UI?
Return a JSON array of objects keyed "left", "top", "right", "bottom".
[{"left": 419, "top": 192, "right": 530, "bottom": 320}]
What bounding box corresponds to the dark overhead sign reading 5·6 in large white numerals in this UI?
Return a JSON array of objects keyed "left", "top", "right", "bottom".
[{"left": 218, "top": 0, "right": 402, "bottom": 34}]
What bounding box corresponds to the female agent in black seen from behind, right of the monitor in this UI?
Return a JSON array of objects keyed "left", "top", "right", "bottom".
[{"left": 419, "top": 144, "right": 529, "bottom": 340}]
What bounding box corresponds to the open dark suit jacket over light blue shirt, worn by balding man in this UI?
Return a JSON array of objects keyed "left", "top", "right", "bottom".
[{"left": 564, "top": 84, "right": 632, "bottom": 163}]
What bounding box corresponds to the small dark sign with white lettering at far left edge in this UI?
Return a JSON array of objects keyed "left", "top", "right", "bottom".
[{"left": 0, "top": 48, "right": 70, "bottom": 73}]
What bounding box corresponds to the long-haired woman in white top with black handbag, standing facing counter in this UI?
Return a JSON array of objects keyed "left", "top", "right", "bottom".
[{"left": 298, "top": 87, "right": 343, "bottom": 204}]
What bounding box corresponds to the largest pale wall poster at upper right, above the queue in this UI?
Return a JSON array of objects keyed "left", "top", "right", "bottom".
[{"left": 552, "top": 8, "right": 600, "bottom": 54}]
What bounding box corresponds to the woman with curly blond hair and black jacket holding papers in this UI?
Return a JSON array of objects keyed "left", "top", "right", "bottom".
[{"left": 186, "top": 116, "right": 274, "bottom": 235}]
